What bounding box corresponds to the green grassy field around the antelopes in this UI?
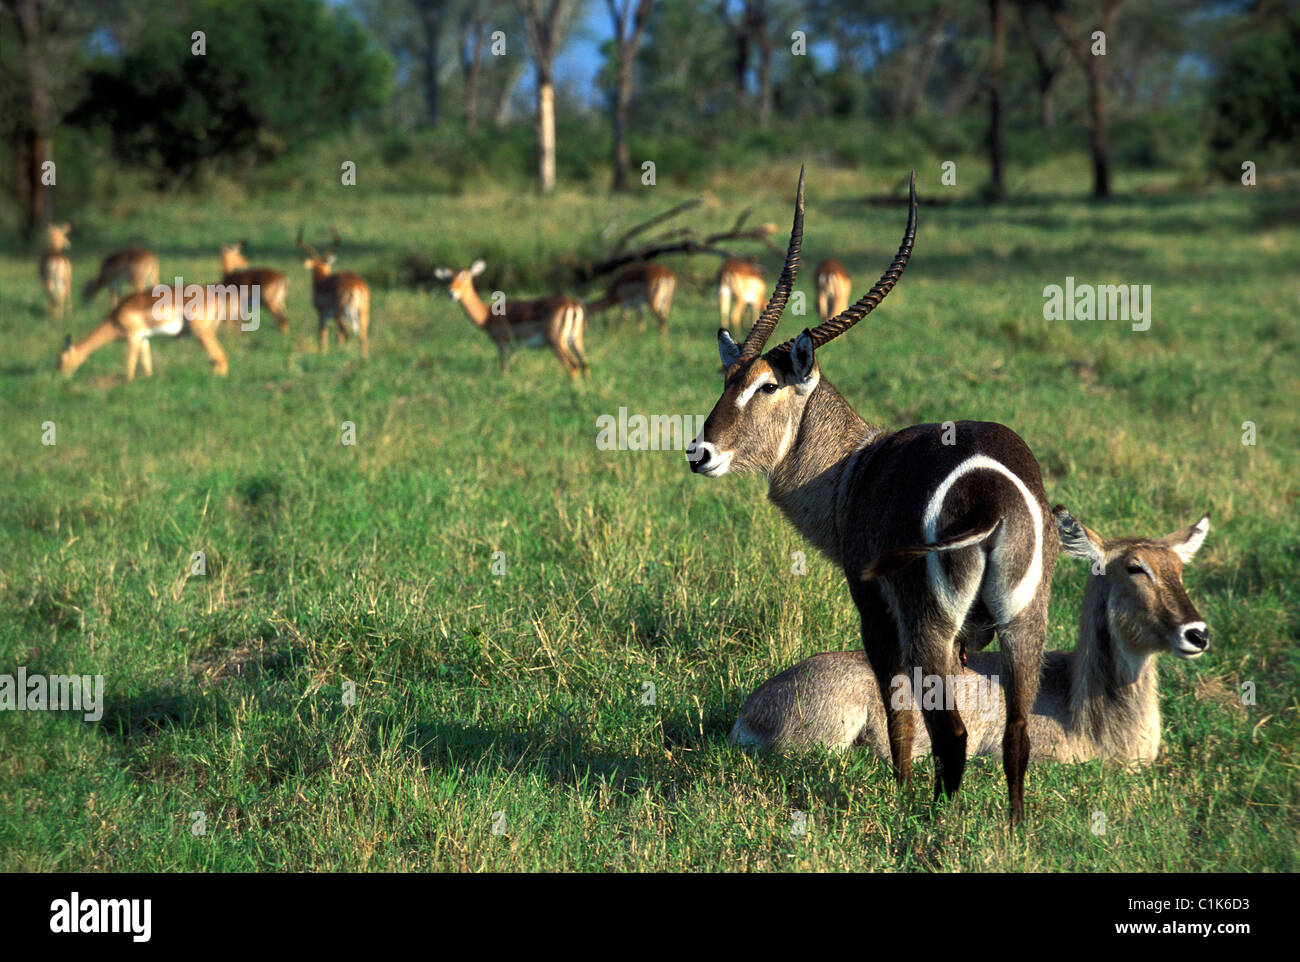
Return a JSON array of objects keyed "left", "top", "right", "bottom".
[{"left": 0, "top": 161, "right": 1300, "bottom": 871}]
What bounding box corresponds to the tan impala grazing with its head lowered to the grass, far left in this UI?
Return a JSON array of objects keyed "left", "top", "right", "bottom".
[{"left": 56, "top": 287, "right": 228, "bottom": 381}]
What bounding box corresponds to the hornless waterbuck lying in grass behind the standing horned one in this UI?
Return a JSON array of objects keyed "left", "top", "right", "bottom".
[{"left": 731, "top": 507, "right": 1210, "bottom": 764}]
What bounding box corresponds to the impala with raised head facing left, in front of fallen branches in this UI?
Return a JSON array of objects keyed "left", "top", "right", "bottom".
[{"left": 434, "top": 259, "right": 590, "bottom": 380}]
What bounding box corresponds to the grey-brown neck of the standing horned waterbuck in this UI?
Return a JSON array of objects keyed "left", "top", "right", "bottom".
[{"left": 767, "top": 377, "right": 883, "bottom": 564}]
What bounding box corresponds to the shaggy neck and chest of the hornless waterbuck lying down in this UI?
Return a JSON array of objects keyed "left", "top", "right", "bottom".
[{"left": 1070, "top": 575, "right": 1160, "bottom": 761}]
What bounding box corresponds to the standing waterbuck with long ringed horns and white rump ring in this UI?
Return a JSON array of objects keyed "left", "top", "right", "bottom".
[{"left": 686, "top": 170, "right": 1057, "bottom": 823}]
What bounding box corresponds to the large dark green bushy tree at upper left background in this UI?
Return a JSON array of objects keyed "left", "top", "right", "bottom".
[{"left": 70, "top": 0, "right": 391, "bottom": 181}]
